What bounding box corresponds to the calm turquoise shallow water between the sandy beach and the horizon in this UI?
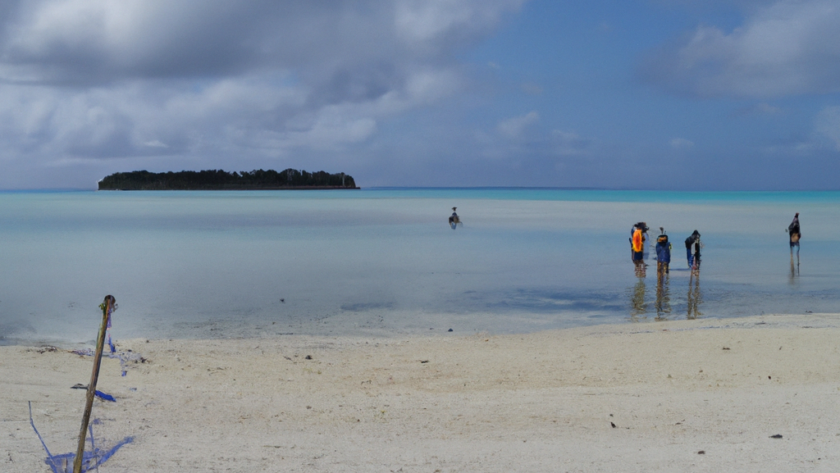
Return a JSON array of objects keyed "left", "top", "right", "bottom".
[{"left": 0, "top": 189, "right": 840, "bottom": 343}]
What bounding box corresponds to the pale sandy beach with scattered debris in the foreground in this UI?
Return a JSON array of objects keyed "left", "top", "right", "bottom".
[{"left": 0, "top": 314, "right": 840, "bottom": 473}]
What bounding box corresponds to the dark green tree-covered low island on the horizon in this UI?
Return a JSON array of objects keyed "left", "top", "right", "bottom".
[{"left": 99, "top": 169, "right": 358, "bottom": 191}]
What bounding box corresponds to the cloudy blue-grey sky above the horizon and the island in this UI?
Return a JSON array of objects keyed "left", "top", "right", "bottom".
[{"left": 0, "top": 0, "right": 840, "bottom": 191}]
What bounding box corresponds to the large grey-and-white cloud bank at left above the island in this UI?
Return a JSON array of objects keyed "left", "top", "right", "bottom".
[{"left": 0, "top": 0, "right": 524, "bottom": 180}]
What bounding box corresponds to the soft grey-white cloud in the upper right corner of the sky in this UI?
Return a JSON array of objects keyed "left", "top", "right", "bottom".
[{"left": 642, "top": 0, "right": 840, "bottom": 97}]
